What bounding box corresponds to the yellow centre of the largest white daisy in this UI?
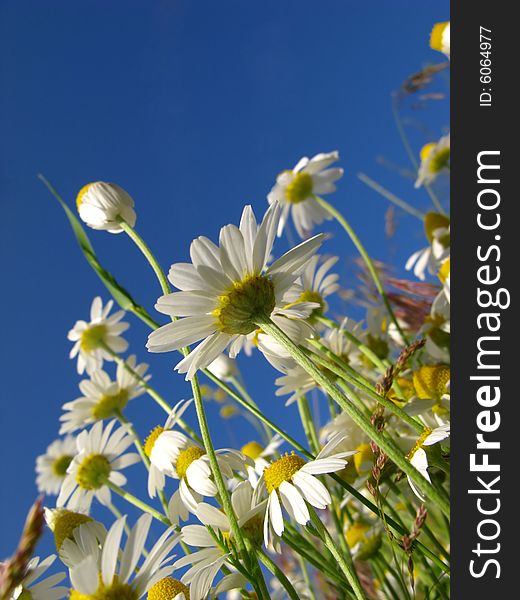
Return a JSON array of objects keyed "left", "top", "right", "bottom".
[{"left": 213, "top": 275, "right": 275, "bottom": 335}]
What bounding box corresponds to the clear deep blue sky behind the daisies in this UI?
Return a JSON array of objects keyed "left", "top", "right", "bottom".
[{"left": 0, "top": 0, "right": 449, "bottom": 558}]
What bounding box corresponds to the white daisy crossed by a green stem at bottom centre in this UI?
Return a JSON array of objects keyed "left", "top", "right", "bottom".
[{"left": 174, "top": 481, "right": 266, "bottom": 600}]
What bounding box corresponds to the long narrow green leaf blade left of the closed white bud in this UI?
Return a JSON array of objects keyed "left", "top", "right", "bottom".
[{"left": 38, "top": 174, "right": 159, "bottom": 329}]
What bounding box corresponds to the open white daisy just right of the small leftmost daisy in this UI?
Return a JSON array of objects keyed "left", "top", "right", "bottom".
[{"left": 56, "top": 421, "right": 140, "bottom": 513}]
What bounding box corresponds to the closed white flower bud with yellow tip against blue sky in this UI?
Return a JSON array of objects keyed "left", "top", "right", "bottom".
[{"left": 76, "top": 181, "right": 136, "bottom": 233}]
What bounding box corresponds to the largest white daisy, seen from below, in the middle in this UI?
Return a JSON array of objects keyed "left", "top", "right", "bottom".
[{"left": 147, "top": 203, "right": 323, "bottom": 379}]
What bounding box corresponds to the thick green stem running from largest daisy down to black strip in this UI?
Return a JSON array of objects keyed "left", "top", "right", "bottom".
[{"left": 257, "top": 317, "right": 450, "bottom": 516}]
